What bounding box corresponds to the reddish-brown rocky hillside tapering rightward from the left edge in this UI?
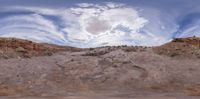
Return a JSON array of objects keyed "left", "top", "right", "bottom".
[{"left": 0, "top": 38, "right": 80, "bottom": 59}]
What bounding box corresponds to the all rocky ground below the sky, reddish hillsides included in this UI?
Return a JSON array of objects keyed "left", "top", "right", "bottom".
[{"left": 0, "top": 37, "right": 200, "bottom": 99}]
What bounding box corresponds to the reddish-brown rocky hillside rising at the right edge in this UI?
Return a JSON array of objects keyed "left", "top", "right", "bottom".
[{"left": 154, "top": 37, "right": 200, "bottom": 58}]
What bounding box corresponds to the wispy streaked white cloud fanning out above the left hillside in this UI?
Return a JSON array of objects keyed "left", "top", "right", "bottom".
[{"left": 0, "top": 14, "right": 64, "bottom": 43}]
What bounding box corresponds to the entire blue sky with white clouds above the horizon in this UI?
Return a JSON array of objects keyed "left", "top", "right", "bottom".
[{"left": 0, "top": 0, "right": 200, "bottom": 48}]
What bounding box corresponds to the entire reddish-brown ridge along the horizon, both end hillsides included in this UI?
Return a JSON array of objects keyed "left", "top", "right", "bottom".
[{"left": 0, "top": 37, "right": 200, "bottom": 59}]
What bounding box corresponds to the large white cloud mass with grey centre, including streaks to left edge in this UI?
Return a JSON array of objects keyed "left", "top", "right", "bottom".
[{"left": 0, "top": 2, "right": 170, "bottom": 47}]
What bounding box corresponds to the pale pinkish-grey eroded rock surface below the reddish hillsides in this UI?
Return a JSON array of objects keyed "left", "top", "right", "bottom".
[{"left": 0, "top": 37, "right": 200, "bottom": 96}]
